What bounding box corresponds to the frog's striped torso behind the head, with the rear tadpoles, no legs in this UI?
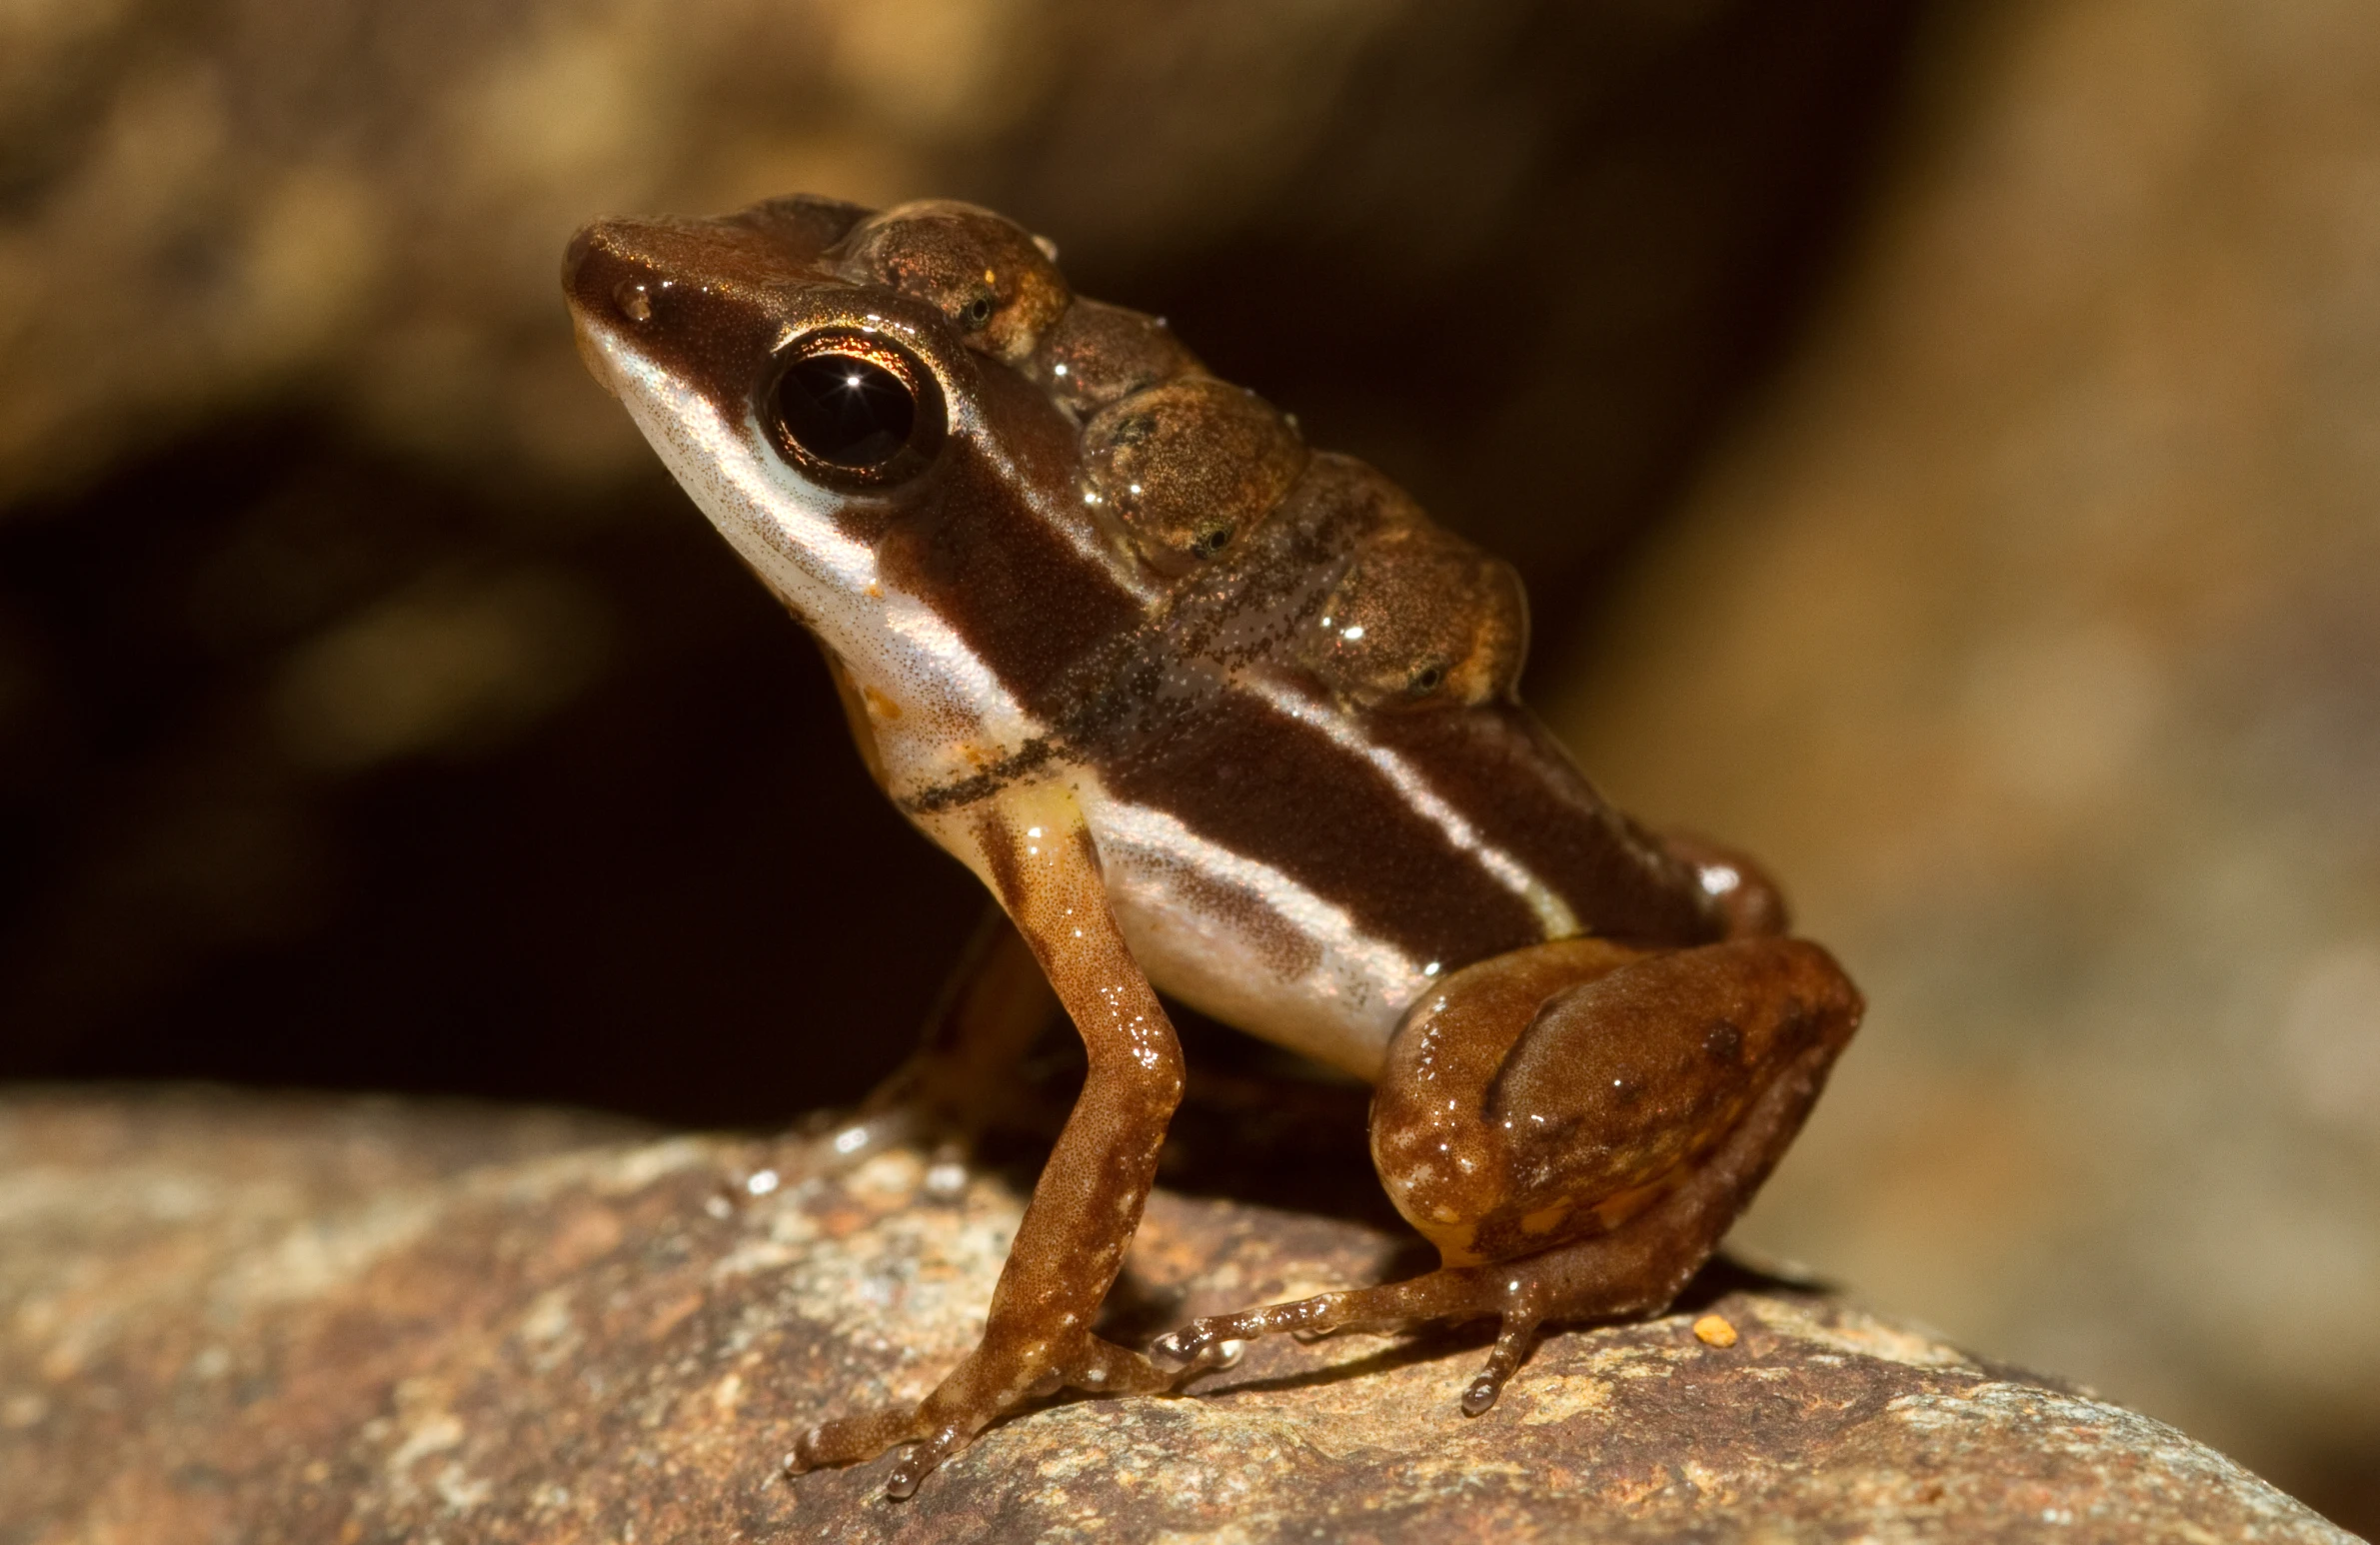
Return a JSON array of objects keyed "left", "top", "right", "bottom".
[{"left": 1062, "top": 440, "right": 1723, "bottom": 1076}]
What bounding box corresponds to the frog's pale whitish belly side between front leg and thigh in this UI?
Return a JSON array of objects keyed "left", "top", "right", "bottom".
[{"left": 1093, "top": 802, "right": 1435, "bottom": 1080}]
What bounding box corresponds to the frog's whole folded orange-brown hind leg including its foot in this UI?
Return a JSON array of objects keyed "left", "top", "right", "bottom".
[{"left": 1157, "top": 935, "right": 1861, "bottom": 1416}]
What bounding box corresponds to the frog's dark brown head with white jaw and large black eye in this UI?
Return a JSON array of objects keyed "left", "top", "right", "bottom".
[{"left": 562, "top": 198, "right": 1194, "bottom": 746}]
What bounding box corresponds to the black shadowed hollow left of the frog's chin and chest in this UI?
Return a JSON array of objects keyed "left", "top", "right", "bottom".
[{"left": 0, "top": 419, "right": 979, "bottom": 1123}]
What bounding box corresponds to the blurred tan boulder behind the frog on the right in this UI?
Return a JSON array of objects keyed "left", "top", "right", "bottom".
[{"left": 1556, "top": 0, "right": 2380, "bottom": 1533}]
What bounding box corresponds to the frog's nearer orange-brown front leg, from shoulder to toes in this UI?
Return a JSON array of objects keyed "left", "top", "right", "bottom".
[{"left": 793, "top": 787, "right": 1183, "bottom": 1497}]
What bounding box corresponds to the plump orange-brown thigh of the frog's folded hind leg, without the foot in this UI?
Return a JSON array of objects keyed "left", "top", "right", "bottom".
[{"left": 1370, "top": 938, "right": 1859, "bottom": 1266}]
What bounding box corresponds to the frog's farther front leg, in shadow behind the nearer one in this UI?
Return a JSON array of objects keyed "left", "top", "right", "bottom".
[{"left": 814, "top": 907, "right": 1062, "bottom": 1190}]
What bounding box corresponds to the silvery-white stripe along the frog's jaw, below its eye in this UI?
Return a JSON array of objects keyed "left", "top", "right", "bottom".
[{"left": 588, "top": 329, "right": 1040, "bottom": 762}]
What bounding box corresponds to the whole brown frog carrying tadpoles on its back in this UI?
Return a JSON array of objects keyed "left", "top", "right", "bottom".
[{"left": 564, "top": 198, "right": 1861, "bottom": 1495}]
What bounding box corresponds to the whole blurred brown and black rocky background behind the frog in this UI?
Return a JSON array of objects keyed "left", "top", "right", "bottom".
[{"left": 0, "top": 0, "right": 2380, "bottom": 1533}]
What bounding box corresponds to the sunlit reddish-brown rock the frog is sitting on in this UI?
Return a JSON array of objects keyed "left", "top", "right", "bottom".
[{"left": 0, "top": 1092, "right": 2349, "bottom": 1545}]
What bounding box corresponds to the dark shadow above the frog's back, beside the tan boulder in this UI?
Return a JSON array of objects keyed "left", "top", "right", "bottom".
[{"left": 1028, "top": 0, "right": 1944, "bottom": 669}]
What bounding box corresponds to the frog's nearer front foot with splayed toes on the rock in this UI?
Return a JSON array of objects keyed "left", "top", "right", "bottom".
[{"left": 786, "top": 1333, "right": 1179, "bottom": 1497}]
